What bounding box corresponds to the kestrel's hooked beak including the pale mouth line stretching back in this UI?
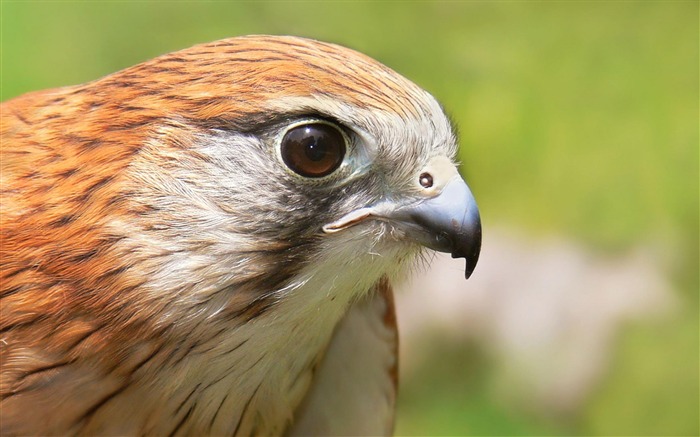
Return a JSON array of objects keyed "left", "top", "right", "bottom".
[{"left": 323, "top": 158, "right": 481, "bottom": 279}]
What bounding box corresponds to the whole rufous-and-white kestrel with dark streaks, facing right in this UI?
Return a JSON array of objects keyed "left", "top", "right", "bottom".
[{"left": 0, "top": 35, "right": 481, "bottom": 436}]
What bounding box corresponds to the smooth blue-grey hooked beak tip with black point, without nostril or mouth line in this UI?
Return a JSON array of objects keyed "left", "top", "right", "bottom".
[{"left": 391, "top": 176, "right": 481, "bottom": 279}]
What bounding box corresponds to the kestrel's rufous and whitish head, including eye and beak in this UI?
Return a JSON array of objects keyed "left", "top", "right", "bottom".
[{"left": 115, "top": 36, "right": 481, "bottom": 277}]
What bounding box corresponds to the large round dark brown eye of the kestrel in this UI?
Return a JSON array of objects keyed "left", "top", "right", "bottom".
[{"left": 280, "top": 122, "right": 345, "bottom": 178}]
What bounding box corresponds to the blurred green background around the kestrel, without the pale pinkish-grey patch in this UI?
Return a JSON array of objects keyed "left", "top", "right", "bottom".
[{"left": 0, "top": 0, "right": 700, "bottom": 435}]
